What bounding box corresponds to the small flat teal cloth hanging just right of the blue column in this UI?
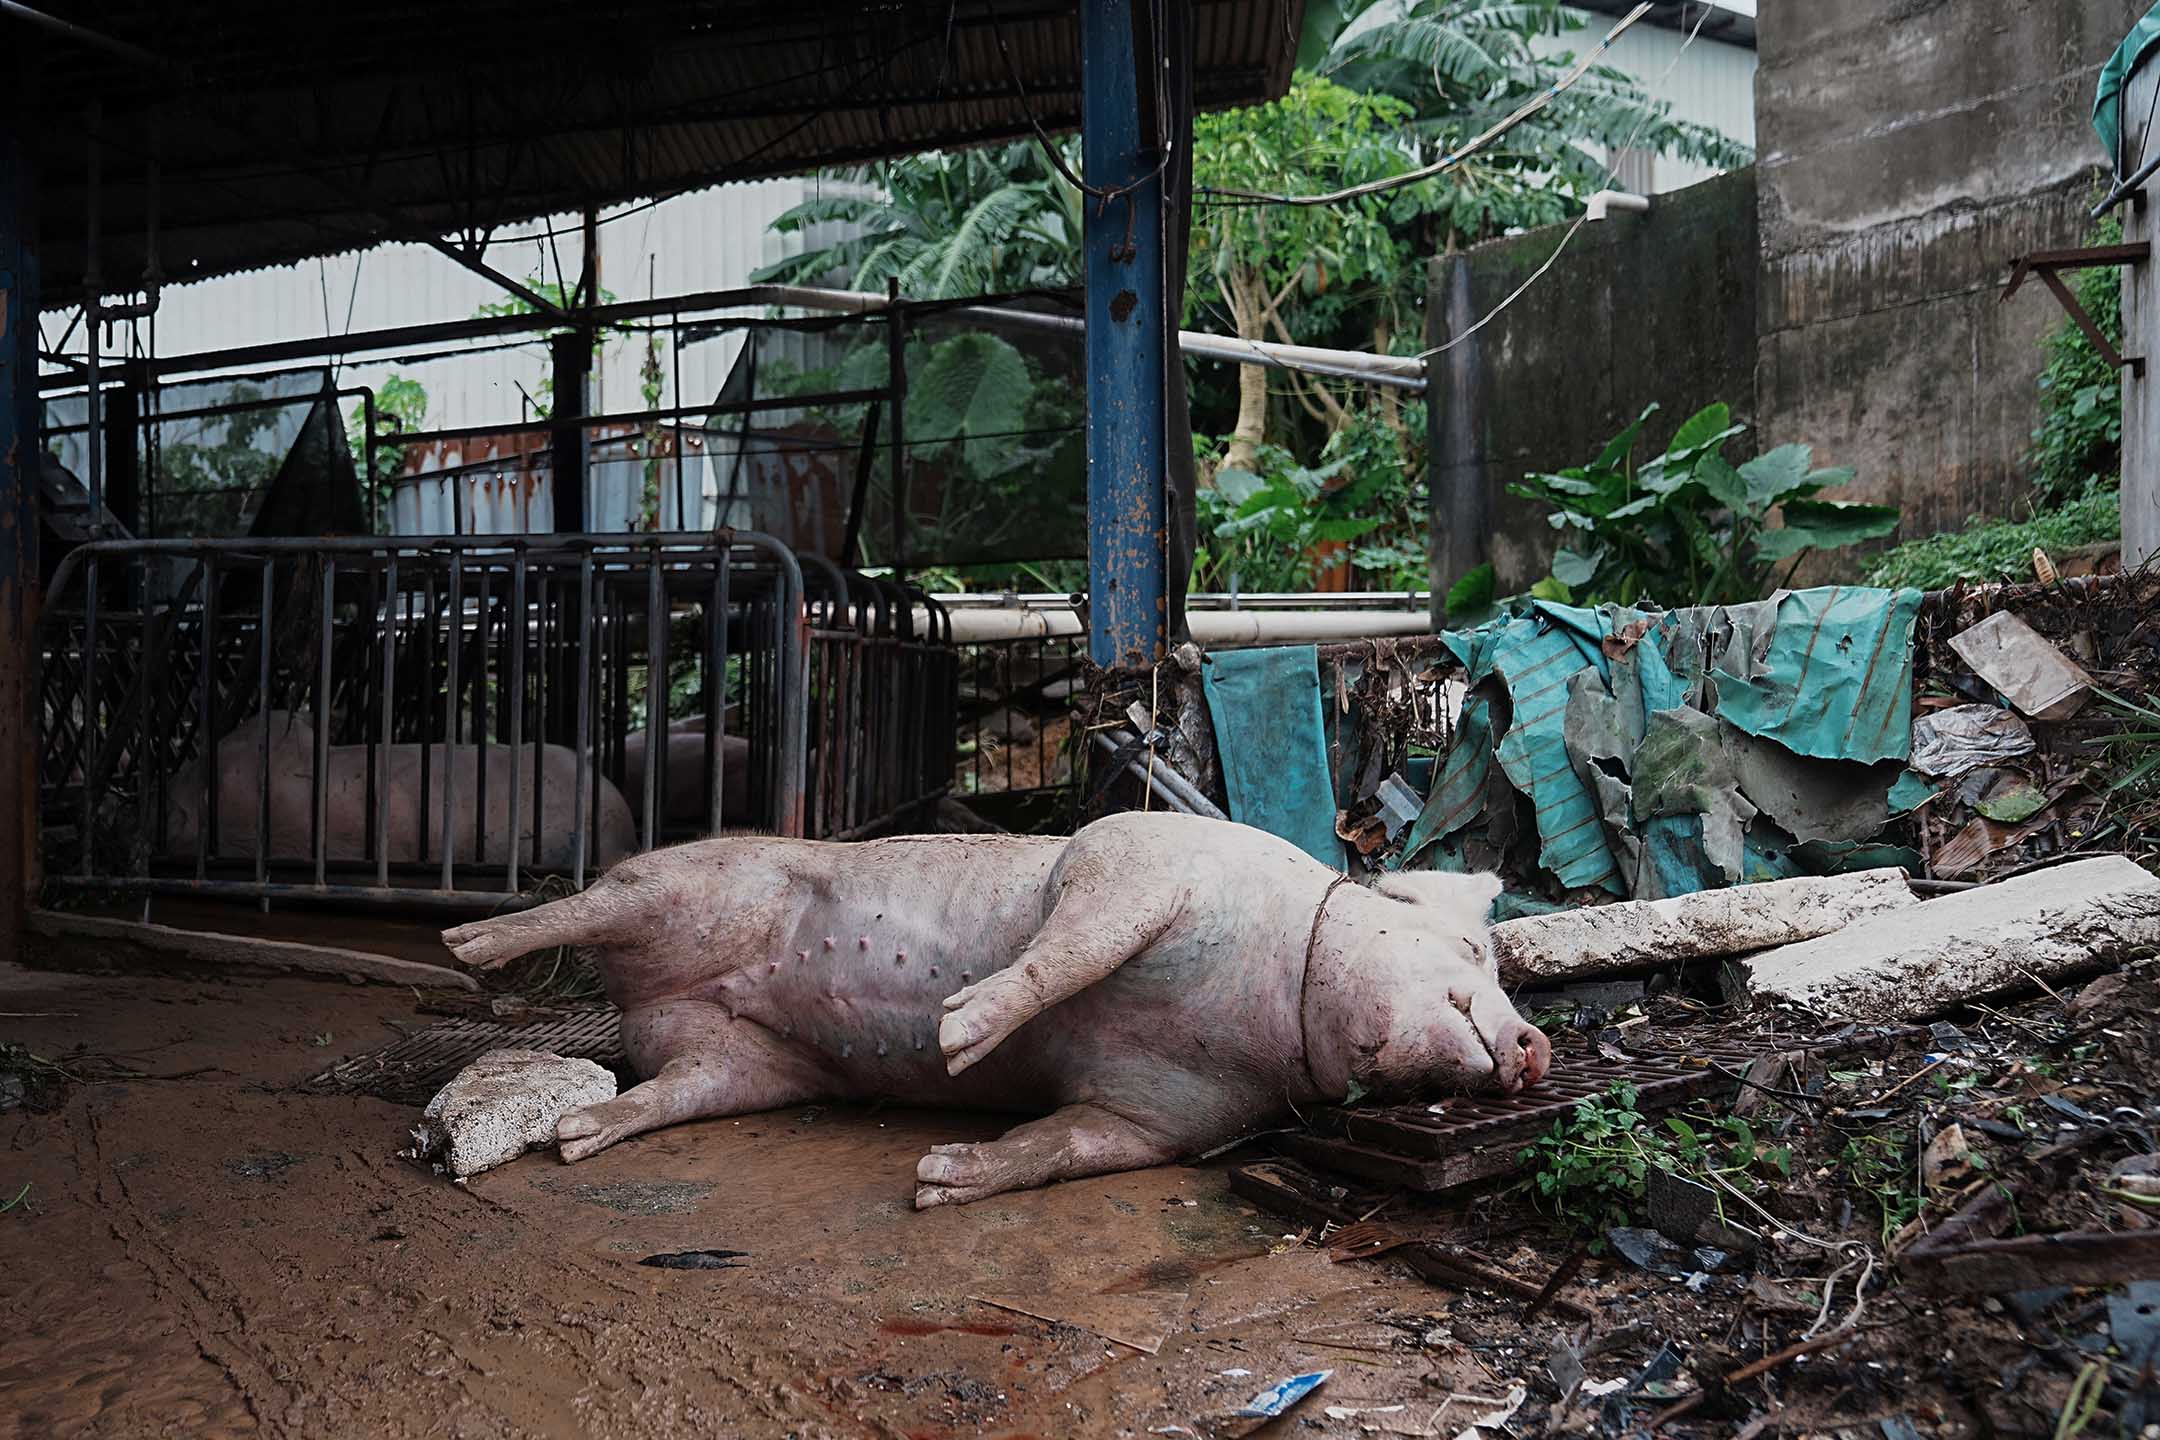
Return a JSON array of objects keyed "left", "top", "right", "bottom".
[{"left": 1201, "top": 646, "right": 1344, "bottom": 870}]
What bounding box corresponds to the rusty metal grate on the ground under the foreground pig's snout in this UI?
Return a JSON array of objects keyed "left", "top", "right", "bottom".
[{"left": 1285, "top": 1036, "right": 1855, "bottom": 1192}]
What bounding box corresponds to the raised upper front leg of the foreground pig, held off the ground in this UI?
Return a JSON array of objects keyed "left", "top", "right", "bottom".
[{"left": 937, "top": 864, "right": 1184, "bottom": 1075}]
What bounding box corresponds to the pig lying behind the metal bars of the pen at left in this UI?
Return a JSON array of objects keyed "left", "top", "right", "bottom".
[{"left": 164, "top": 710, "right": 637, "bottom": 868}]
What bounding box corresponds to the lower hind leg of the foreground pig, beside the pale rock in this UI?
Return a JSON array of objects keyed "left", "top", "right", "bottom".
[{"left": 555, "top": 1000, "right": 832, "bottom": 1164}]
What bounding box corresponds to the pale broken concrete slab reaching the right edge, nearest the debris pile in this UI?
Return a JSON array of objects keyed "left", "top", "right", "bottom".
[{"left": 1747, "top": 855, "right": 2160, "bottom": 1023}]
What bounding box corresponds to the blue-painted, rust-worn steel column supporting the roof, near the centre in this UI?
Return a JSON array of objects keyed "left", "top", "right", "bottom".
[{"left": 1080, "top": 0, "right": 1177, "bottom": 665}]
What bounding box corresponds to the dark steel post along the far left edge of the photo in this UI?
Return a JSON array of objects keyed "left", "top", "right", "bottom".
[{"left": 0, "top": 59, "right": 41, "bottom": 952}]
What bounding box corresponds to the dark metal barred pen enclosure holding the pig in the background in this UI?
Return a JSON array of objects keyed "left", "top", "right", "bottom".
[{"left": 37, "top": 531, "right": 950, "bottom": 909}]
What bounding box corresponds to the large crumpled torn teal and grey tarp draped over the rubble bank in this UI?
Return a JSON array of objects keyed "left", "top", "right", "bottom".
[{"left": 1398, "top": 587, "right": 1925, "bottom": 898}]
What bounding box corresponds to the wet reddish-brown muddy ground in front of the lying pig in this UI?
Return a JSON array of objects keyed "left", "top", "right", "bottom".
[{"left": 0, "top": 949, "right": 1520, "bottom": 1440}]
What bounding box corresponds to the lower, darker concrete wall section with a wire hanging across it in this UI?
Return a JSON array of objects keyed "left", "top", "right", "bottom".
[{"left": 1428, "top": 171, "right": 1756, "bottom": 594}]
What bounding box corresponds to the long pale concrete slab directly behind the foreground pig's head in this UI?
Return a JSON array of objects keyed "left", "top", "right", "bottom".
[{"left": 1493, "top": 866, "right": 1918, "bottom": 984}]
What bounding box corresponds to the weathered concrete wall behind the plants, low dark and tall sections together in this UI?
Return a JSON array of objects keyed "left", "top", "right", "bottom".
[{"left": 1428, "top": 0, "right": 2160, "bottom": 589}]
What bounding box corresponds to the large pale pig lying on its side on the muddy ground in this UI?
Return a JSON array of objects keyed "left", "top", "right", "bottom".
[{"left": 443, "top": 814, "right": 1551, "bottom": 1207}]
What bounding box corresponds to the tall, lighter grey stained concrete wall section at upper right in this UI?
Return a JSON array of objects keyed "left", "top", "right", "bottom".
[{"left": 1756, "top": 0, "right": 2147, "bottom": 546}]
